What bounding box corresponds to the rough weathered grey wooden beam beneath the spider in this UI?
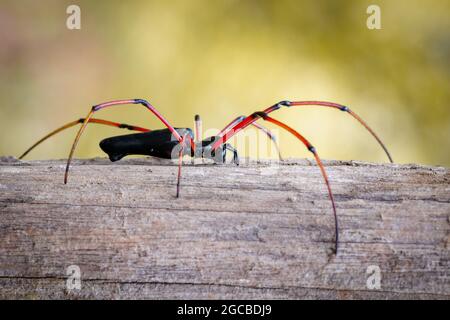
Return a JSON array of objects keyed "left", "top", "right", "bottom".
[{"left": 0, "top": 158, "right": 450, "bottom": 299}]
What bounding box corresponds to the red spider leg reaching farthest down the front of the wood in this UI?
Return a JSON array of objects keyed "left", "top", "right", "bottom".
[{"left": 256, "top": 112, "right": 339, "bottom": 254}]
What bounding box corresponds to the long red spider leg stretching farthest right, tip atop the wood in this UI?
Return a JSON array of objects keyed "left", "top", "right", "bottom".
[{"left": 213, "top": 101, "right": 393, "bottom": 163}]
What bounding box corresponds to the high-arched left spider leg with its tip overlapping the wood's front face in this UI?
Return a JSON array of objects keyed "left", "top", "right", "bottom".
[{"left": 64, "top": 99, "right": 183, "bottom": 184}]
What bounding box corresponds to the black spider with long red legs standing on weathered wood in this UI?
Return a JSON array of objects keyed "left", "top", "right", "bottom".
[{"left": 19, "top": 99, "right": 393, "bottom": 254}]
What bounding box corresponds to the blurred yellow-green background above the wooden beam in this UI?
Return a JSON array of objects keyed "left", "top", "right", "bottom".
[{"left": 0, "top": 0, "right": 450, "bottom": 166}]
